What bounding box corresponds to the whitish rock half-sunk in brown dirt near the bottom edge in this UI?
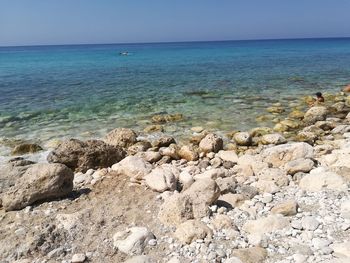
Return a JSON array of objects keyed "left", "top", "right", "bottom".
[{"left": 113, "top": 227, "right": 156, "bottom": 255}]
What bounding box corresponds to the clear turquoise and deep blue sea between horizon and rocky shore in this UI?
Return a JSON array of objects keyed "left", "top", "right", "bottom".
[{"left": 0, "top": 39, "right": 350, "bottom": 153}]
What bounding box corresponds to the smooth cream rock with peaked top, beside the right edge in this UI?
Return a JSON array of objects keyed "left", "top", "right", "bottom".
[{"left": 299, "top": 167, "right": 347, "bottom": 192}]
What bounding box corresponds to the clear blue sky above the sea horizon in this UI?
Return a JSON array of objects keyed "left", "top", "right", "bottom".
[{"left": 0, "top": 0, "right": 350, "bottom": 46}]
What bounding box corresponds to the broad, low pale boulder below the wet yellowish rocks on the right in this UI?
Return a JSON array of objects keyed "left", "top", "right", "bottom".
[{"left": 260, "top": 142, "right": 314, "bottom": 167}]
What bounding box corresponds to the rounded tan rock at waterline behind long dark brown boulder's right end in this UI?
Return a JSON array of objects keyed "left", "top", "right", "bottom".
[{"left": 104, "top": 128, "right": 137, "bottom": 148}]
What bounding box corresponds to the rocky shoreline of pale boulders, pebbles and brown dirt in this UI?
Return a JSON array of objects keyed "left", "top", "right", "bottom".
[{"left": 0, "top": 89, "right": 350, "bottom": 263}]
